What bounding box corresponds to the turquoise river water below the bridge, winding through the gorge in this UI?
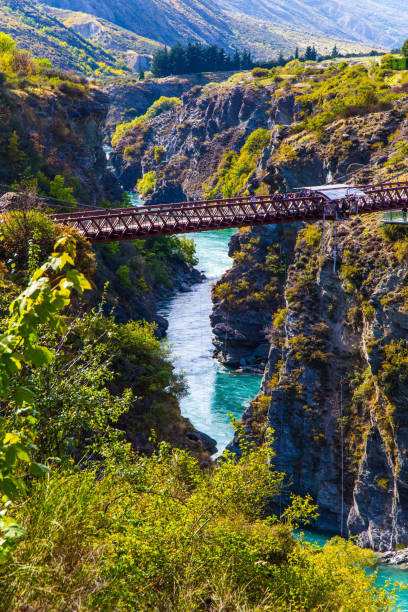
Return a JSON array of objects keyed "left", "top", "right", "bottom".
[{"left": 158, "top": 227, "right": 408, "bottom": 612}]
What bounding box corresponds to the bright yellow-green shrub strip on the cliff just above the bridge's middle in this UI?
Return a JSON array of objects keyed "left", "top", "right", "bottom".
[{"left": 205, "top": 128, "right": 271, "bottom": 200}]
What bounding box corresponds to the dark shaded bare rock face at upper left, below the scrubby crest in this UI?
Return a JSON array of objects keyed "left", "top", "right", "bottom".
[{"left": 0, "top": 81, "right": 122, "bottom": 205}]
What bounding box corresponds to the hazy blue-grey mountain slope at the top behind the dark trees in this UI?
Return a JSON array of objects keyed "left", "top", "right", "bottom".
[{"left": 41, "top": 0, "right": 377, "bottom": 60}]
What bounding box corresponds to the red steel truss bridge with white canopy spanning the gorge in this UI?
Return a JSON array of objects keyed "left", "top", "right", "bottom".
[{"left": 51, "top": 181, "right": 408, "bottom": 243}]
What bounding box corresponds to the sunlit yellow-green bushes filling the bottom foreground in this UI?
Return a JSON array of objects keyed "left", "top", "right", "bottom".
[{"left": 0, "top": 435, "right": 393, "bottom": 612}]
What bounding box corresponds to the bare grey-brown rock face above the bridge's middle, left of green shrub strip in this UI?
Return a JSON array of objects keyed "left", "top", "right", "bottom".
[{"left": 112, "top": 80, "right": 294, "bottom": 202}]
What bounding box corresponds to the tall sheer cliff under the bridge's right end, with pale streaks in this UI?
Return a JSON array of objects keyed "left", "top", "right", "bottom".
[{"left": 225, "top": 216, "right": 408, "bottom": 551}]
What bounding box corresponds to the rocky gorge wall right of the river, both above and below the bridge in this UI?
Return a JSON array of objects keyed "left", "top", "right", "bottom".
[{"left": 111, "top": 67, "right": 408, "bottom": 550}]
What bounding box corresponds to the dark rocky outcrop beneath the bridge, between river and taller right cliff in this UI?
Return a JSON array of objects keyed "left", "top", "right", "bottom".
[{"left": 211, "top": 225, "right": 296, "bottom": 372}]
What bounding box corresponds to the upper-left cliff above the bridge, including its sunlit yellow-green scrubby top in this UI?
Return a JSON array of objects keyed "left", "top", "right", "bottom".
[{"left": 0, "top": 33, "right": 120, "bottom": 203}]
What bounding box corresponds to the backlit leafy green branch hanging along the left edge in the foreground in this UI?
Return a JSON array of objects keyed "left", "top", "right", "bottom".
[{"left": 0, "top": 239, "right": 91, "bottom": 563}]
